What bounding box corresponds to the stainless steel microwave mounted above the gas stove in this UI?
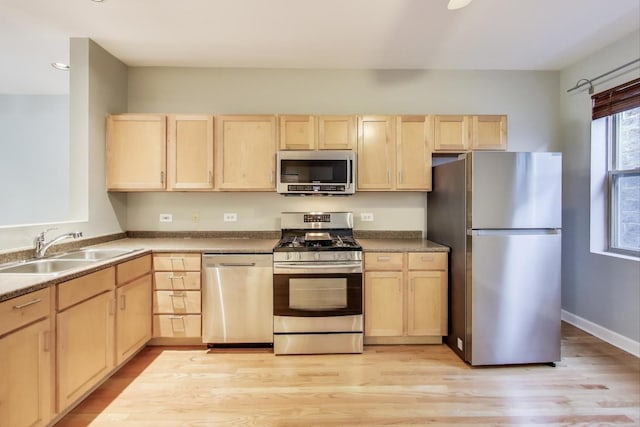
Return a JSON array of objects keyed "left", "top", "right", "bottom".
[{"left": 276, "top": 150, "right": 356, "bottom": 195}]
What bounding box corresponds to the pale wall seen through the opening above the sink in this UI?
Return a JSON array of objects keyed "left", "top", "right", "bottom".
[{"left": 0, "top": 95, "right": 70, "bottom": 227}]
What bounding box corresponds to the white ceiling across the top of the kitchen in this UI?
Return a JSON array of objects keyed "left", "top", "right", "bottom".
[{"left": 0, "top": 0, "right": 640, "bottom": 93}]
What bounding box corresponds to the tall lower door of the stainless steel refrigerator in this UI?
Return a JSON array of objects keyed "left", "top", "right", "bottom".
[{"left": 467, "top": 230, "right": 561, "bottom": 365}]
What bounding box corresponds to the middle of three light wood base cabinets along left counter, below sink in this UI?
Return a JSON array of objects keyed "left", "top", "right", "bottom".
[{"left": 56, "top": 267, "right": 116, "bottom": 412}]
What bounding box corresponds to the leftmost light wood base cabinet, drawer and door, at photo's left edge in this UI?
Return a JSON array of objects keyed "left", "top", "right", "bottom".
[{"left": 0, "top": 288, "right": 53, "bottom": 427}]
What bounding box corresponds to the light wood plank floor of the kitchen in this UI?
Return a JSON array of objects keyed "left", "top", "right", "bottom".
[{"left": 56, "top": 324, "right": 640, "bottom": 427}]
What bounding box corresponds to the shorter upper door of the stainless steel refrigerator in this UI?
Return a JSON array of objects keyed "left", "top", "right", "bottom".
[{"left": 467, "top": 152, "right": 562, "bottom": 229}]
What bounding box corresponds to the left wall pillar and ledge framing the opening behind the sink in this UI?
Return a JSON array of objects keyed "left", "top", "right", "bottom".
[{"left": 0, "top": 38, "right": 127, "bottom": 251}]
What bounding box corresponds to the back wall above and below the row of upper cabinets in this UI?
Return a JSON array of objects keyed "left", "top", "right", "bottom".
[{"left": 127, "top": 67, "right": 560, "bottom": 233}]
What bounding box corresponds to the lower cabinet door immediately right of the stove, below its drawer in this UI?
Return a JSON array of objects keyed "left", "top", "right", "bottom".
[{"left": 364, "top": 271, "right": 403, "bottom": 337}]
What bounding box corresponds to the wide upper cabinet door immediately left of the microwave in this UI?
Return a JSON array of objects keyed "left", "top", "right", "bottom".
[{"left": 216, "top": 115, "right": 276, "bottom": 191}]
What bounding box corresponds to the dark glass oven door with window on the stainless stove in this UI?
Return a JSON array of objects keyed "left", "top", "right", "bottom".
[{"left": 273, "top": 265, "right": 362, "bottom": 317}]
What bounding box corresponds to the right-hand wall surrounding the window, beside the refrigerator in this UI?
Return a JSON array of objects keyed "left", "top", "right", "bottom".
[{"left": 560, "top": 32, "right": 640, "bottom": 352}]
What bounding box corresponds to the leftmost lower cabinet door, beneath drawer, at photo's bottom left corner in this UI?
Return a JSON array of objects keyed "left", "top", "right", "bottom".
[{"left": 0, "top": 318, "right": 52, "bottom": 427}]
